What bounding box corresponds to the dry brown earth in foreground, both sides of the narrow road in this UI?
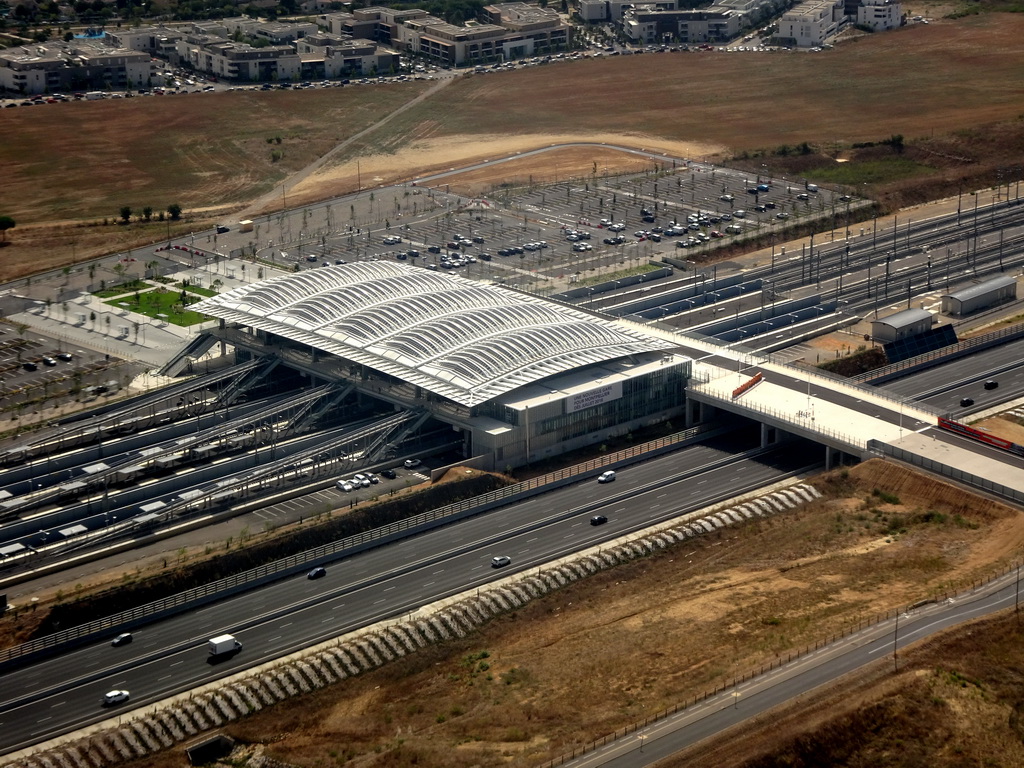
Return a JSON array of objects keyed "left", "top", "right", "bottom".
[{"left": 99, "top": 460, "right": 1024, "bottom": 768}]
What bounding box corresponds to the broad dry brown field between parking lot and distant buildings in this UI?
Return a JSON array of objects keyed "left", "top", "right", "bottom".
[{"left": 6, "top": 14, "right": 1024, "bottom": 279}]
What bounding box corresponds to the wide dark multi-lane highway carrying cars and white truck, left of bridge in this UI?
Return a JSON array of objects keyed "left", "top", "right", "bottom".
[{"left": 0, "top": 439, "right": 818, "bottom": 752}]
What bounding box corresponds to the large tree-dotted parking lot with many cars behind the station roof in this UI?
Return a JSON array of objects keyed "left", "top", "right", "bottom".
[{"left": 239, "top": 158, "right": 847, "bottom": 293}]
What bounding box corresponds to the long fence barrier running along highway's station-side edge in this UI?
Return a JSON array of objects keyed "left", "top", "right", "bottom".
[{"left": 0, "top": 426, "right": 714, "bottom": 669}]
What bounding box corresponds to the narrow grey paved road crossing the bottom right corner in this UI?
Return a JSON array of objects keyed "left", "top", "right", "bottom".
[{"left": 565, "top": 571, "right": 1017, "bottom": 768}]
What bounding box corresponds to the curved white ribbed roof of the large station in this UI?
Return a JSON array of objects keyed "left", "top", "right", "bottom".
[{"left": 193, "top": 261, "right": 673, "bottom": 406}]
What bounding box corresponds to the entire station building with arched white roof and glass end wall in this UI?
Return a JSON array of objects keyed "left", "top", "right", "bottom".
[{"left": 195, "top": 261, "right": 692, "bottom": 469}]
